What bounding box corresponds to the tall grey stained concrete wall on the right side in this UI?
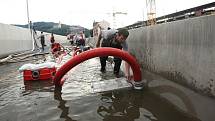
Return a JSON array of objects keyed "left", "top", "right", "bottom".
[{"left": 128, "top": 15, "right": 215, "bottom": 96}]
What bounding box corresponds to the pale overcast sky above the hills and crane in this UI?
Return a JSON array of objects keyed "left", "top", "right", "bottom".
[{"left": 0, "top": 0, "right": 214, "bottom": 29}]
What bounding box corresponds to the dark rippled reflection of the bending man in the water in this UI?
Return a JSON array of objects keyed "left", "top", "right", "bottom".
[{"left": 97, "top": 91, "right": 143, "bottom": 121}]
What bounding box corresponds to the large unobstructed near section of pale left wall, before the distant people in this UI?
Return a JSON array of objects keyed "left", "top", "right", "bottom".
[{"left": 0, "top": 23, "right": 32, "bottom": 56}]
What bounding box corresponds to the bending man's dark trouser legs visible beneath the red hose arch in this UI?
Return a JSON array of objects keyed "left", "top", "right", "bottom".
[{"left": 100, "top": 56, "right": 122, "bottom": 74}]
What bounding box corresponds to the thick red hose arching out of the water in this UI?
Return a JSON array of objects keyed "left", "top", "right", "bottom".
[{"left": 54, "top": 47, "right": 142, "bottom": 89}]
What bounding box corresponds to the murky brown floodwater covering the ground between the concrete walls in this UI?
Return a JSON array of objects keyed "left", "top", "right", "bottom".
[{"left": 0, "top": 53, "right": 215, "bottom": 121}]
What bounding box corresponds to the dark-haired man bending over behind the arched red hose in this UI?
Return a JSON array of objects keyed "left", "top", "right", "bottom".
[{"left": 96, "top": 29, "right": 129, "bottom": 77}]
